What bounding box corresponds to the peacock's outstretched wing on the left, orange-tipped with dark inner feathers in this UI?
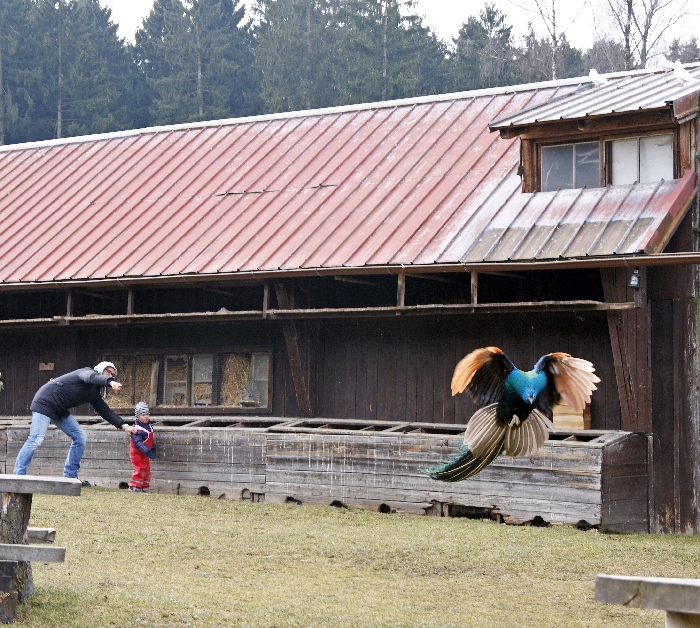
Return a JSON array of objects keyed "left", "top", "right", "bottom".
[{"left": 452, "top": 347, "right": 515, "bottom": 407}]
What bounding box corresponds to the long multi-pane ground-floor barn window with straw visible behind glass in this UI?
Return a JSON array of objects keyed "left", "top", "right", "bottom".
[{"left": 103, "top": 350, "right": 272, "bottom": 411}]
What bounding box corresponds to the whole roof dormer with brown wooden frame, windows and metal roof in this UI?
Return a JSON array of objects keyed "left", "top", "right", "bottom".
[{"left": 489, "top": 65, "right": 700, "bottom": 192}]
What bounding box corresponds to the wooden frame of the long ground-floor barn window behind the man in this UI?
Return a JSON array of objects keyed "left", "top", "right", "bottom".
[{"left": 97, "top": 345, "right": 275, "bottom": 416}]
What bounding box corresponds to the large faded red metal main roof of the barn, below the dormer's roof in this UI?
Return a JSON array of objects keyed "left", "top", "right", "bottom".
[{"left": 0, "top": 76, "right": 694, "bottom": 284}]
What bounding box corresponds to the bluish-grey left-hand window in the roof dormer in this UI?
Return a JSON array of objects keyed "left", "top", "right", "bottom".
[{"left": 541, "top": 142, "right": 600, "bottom": 192}]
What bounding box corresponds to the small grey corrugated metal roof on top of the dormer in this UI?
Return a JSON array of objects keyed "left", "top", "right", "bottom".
[{"left": 490, "top": 64, "right": 700, "bottom": 130}]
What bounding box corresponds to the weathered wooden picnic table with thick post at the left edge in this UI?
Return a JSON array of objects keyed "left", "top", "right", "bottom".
[{"left": 0, "top": 474, "right": 82, "bottom": 623}]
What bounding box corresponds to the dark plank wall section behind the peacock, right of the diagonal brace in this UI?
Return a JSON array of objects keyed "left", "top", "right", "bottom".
[{"left": 312, "top": 314, "right": 621, "bottom": 429}]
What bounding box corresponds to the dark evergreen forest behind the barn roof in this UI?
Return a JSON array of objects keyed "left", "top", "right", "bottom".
[{"left": 0, "top": 0, "right": 698, "bottom": 144}]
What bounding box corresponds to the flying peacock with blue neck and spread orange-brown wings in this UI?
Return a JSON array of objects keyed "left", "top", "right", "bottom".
[{"left": 428, "top": 347, "right": 600, "bottom": 482}]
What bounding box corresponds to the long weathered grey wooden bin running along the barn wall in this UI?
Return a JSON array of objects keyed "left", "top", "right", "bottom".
[{"left": 0, "top": 417, "right": 648, "bottom": 532}]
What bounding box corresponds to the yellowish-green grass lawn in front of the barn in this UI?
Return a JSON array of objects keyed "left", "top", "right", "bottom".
[{"left": 18, "top": 488, "right": 700, "bottom": 628}]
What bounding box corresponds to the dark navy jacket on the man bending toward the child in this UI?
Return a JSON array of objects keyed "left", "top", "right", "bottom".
[{"left": 29, "top": 367, "right": 124, "bottom": 428}]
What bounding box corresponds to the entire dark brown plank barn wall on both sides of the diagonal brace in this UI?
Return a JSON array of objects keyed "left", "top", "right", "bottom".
[{"left": 0, "top": 313, "right": 621, "bottom": 429}]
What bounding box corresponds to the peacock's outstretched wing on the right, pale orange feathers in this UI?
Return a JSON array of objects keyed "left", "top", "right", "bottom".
[{"left": 535, "top": 352, "right": 600, "bottom": 416}]
